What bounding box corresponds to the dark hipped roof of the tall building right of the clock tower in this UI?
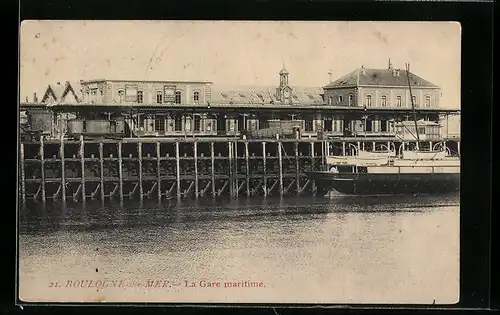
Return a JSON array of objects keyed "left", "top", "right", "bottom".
[{"left": 324, "top": 68, "right": 438, "bottom": 89}]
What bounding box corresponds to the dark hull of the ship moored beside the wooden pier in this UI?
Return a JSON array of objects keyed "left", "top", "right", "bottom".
[{"left": 308, "top": 172, "right": 460, "bottom": 195}]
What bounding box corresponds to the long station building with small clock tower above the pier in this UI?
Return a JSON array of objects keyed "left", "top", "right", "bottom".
[{"left": 21, "top": 61, "right": 458, "bottom": 142}]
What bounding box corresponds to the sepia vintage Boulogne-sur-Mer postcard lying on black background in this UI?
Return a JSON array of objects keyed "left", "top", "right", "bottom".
[{"left": 18, "top": 20, "right": 461, "bottom": 304}]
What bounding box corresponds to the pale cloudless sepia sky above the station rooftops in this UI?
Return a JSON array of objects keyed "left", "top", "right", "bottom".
[{"left": 20, "top": 21, "right": 461, "bottom": 108}]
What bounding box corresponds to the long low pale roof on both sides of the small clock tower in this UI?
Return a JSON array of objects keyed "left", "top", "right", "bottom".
[{"left": 210, "top": 86, "right": 323, "bottom": 104}]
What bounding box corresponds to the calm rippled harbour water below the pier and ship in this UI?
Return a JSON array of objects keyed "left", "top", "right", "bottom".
[{"left": 19, "top": 195, "right": 459, "bottom": 304}]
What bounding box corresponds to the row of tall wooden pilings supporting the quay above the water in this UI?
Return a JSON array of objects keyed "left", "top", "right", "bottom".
[{"left": 19, "top": 137, "right": 459, "bottom": 203}]
